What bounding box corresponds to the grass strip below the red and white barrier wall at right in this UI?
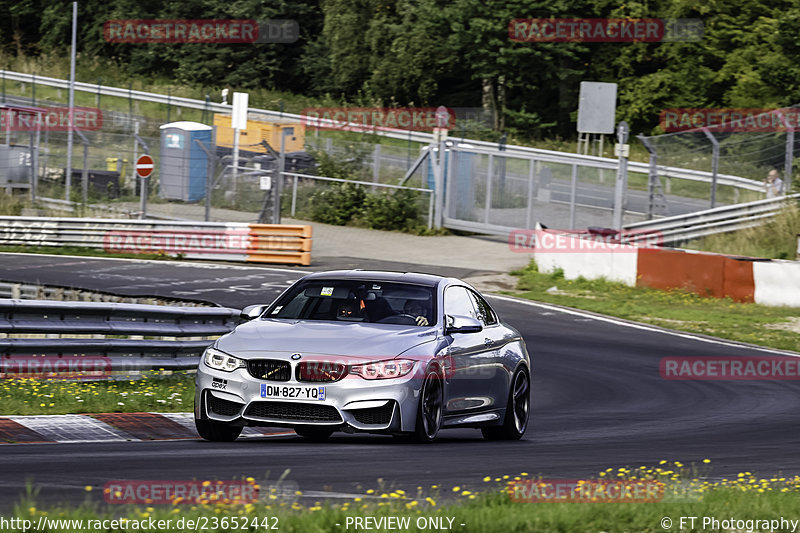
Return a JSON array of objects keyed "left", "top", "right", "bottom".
[{"left": 514, "top": 263, "right": 800, "bottom": 351}]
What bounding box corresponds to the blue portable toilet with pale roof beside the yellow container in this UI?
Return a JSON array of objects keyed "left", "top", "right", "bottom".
[{"left": 158, "top": 120, "right": 213, "bottom": 202}]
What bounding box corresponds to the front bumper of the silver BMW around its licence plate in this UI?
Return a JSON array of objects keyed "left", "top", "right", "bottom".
[{"left": 195, "top": 361, "right": 422, "bottom": 433}]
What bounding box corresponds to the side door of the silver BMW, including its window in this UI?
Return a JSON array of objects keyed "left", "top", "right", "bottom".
[{"left": 444, "top": 285, "right": 495, "bottom": 415}]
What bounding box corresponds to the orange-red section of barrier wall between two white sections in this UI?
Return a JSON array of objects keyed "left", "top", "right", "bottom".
[{"left": 636, "top": 248, "right": 755, "bottom": 302}]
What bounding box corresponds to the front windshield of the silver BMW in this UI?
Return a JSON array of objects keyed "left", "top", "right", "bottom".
[{"left": 265, "top": 279, "right": 436, "bottom": 326}]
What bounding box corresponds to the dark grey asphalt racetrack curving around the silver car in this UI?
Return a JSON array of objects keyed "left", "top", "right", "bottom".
[{"left": 0, "top": 255, "right": 800, "bottom": 508}]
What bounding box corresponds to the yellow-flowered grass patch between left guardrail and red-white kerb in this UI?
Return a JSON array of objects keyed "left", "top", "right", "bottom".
[{"left": 0, "top": 372, "right": 194, "bottom": 415}]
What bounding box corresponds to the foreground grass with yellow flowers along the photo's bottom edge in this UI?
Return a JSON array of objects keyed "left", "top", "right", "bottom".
[{"left": 6, "top": 461, "right": 800, "bottom": 533}]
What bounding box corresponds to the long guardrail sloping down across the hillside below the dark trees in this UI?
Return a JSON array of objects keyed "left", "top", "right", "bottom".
[{"left": 0, "top": 70, "right": 764, "bottom": 191}]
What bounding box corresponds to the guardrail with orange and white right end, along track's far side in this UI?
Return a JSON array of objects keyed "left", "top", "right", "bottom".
[{"left": 0, "top": 216, "right": 311, "bottom": 265}]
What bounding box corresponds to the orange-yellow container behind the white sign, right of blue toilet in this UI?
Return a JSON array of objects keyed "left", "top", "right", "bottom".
[{"left": 214, "top": 113, "right": 306, "bottom": 153}]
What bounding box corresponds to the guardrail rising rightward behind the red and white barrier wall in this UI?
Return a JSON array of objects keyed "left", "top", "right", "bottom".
[{"left": 625, "top": 194, "right": 800, "bottom": 244}]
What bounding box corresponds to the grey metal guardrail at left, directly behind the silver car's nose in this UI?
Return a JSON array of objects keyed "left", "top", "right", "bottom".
[{"left": 0, "top": 299, "right": 240, "bottom": 375}]
